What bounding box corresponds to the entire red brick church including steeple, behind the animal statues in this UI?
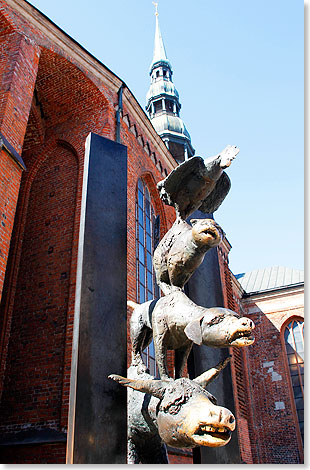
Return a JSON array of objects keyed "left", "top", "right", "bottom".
[{"left": 0, "top": 0, "right": 303, "bottom": 464}]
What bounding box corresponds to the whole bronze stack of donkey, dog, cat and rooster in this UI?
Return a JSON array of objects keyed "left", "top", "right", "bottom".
[{"left": 109, "top": 146, "right": 254, "bottom": 464}]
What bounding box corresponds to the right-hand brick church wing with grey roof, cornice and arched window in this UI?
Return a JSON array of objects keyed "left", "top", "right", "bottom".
[{"left": 218, "top": 235, "right": 304, "bottom": 464}]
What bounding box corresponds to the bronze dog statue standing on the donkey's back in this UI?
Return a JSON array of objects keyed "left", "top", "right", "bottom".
[{"left": 130, "top": 290, "right": 254, "bottom": 379}]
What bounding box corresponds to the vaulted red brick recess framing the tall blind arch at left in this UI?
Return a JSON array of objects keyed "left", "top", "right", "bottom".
[{"left": 0, "top": 37, "right": 114, "bottom": 412}]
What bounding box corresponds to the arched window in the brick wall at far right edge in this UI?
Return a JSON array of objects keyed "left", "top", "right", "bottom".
[{"left": 284, "top": 319, "right": 304, "bottom": 440}]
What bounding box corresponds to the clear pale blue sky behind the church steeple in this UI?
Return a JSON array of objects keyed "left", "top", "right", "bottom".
[{"left": 30, "top": 0, "right": 304, "bottom": 274}]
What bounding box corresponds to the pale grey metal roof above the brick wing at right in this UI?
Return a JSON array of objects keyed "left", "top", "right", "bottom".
[{"left": 235, "top": 266, "right": 304, "bottom": 293}]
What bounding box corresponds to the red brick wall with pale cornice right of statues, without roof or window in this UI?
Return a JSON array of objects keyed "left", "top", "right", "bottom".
[{"left": 218, "top": 244, "right": 303, "bottom": 464}]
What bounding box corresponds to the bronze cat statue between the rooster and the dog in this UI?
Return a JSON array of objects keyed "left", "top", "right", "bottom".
[{"left": 153, "top": 218, "right": 223, "bottom": 294}]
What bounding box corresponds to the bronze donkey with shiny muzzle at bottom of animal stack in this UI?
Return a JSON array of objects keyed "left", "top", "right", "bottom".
[{"left": 109, "top": 358, "right": 235, "bottom": 464}]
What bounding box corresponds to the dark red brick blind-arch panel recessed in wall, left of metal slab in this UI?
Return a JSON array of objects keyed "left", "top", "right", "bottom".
[{"left": 0, "top": 146, "right": 77, "bottom": 432}]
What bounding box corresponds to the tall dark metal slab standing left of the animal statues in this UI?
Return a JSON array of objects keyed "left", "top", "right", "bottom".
[{"left": 67, "top": 133, "right": 127, "bottom": 464}]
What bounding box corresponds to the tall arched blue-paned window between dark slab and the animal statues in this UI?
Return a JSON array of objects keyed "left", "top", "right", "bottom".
[{"left": 136, "top": 179, "right": 159, "bottom": 376}]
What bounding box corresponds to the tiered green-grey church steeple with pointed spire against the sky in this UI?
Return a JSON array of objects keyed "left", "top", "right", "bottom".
[{"left": 146, "top": 2, "right": 195, "bottom": 163}]
